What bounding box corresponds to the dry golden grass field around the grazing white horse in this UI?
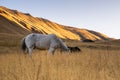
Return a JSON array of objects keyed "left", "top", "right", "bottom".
[{"left": 0, "top": 35, "right": 120, "bottom": 80}]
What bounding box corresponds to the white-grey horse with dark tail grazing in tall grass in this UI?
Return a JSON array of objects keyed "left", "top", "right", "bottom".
[{"left": 21, "top": 33, "right": 69, "bottom": 55}]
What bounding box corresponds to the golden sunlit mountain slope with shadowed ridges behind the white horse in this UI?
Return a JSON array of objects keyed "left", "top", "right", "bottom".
[{"left": 0, "top": 6, "right": 108, "bottom": 40}]
